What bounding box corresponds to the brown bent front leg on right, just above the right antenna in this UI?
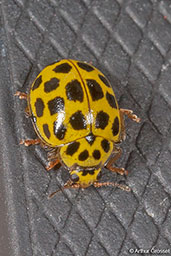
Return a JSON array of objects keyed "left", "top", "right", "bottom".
[{"left": 105, "top": 148, "right": 128, "bottom": 175}]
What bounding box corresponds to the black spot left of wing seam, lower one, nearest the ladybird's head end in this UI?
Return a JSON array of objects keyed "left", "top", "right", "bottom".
[{"left": 70, "top": 111, "right": 87, "bottom": 130}]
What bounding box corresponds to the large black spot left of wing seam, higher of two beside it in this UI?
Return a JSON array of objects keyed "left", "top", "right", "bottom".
[{"left": 66, "top": 79, "right": 83, "bottom": 102}]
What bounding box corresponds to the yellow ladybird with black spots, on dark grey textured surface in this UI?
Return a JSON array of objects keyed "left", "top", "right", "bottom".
[{"left": 16, "top": 59, "right": 140, "bottom": 196}]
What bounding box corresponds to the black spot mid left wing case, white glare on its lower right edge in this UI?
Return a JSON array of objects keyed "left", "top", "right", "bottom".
[{"left": 48, "top": 97, "right": 64, "bottom": 115}]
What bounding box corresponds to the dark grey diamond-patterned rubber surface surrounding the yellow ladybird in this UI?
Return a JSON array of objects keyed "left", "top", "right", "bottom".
[{"left": 0, "top": 0, "right": 171, "bottom": 256}]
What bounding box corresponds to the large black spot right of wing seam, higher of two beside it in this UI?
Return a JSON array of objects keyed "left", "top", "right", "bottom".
[{"left": 86, "top": 79, "right": 104, "bottom": 101}]
